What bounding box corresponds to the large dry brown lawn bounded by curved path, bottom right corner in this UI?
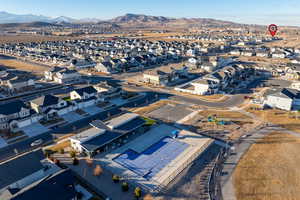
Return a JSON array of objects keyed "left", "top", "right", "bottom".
[{"left": 233, "top": 132, "right": 300, "bottom": 200}]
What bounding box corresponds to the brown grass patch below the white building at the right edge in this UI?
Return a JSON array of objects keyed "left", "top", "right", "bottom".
[{"left": 246, "top": 106, "right": 300, "bottom": 133}]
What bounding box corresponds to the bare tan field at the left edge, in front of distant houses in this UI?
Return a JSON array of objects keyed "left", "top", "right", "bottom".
[{"left": 0, "top": 59, "right": 49, "bottom": 74}]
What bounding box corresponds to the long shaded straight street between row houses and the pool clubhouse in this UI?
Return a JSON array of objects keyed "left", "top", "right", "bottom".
[{"left": 0, "top": 92, "right": 159, "bottom": 161}]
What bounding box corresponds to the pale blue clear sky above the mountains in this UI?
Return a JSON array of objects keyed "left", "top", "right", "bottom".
[{"left": 0, "top": 0, "right": 300, "bottom": 26}]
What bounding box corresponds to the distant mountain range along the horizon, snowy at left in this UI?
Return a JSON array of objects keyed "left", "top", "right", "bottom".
[{"left": 0, "top": 11, "right": 243, "bottom": 27}]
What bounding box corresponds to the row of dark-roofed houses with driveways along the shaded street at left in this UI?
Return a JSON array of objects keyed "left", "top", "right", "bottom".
[{"left": 0, "top": 82, "right": 123, "bottom": 131}]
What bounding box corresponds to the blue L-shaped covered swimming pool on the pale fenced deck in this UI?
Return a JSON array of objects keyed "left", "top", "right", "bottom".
[{"left": 114, "top": 137, "right": 189, "bottom": 180}]
